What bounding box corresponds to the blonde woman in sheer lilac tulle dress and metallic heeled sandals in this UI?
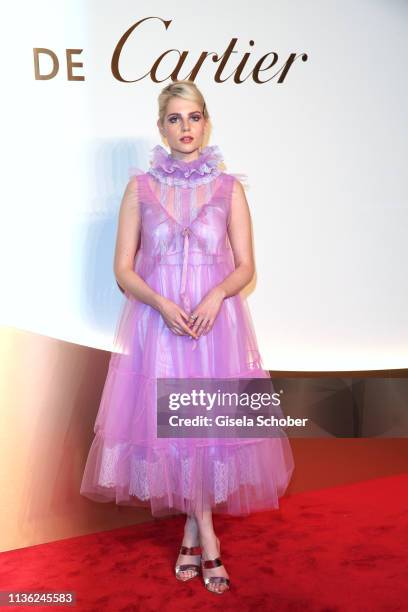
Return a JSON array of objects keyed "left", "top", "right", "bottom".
[{"left": 81, "top": 81, "right": 294, "bottom": 594}]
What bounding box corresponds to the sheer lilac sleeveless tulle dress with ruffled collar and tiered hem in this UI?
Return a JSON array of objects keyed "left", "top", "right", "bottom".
[{"left": 80, "top": 145, "right": 294, "bottom": 516}]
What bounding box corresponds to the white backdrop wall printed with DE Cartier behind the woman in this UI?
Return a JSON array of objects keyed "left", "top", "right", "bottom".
[{"left": 1, "top": 0, "right": 408, "bottom": 370}]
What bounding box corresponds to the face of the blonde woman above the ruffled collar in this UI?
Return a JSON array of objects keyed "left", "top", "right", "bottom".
[{"left": 157, "top": 97, "right": 207, "bottom": 160}]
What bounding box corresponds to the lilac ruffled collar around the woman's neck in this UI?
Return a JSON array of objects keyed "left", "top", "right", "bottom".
[{"left": 147, "top": 145, "right": 223, "bottom": 187}]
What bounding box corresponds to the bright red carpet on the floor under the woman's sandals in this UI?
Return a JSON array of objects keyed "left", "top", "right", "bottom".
[{"left": 1, "top": 474, "right": 408, "bottom": 612}]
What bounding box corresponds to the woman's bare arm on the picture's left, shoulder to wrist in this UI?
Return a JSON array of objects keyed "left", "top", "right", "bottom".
[{"left": 113, "top": 177, "right": 162, "bottom": 310}]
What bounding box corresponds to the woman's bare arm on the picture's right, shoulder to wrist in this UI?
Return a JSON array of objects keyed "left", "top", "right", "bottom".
[{"left": 217, "top": 179, "right": 255, "bottom": 297}]
